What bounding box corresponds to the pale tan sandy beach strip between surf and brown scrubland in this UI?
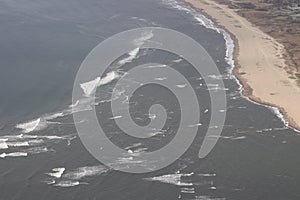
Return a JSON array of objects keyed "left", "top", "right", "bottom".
[{"left": 184, "top": 0, "right": 300, "bottom": 130}]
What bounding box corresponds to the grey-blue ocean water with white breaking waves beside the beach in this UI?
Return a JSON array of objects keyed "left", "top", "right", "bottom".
[{"left": 0, "top": 0, "right": 300, "bottom": 200}]
